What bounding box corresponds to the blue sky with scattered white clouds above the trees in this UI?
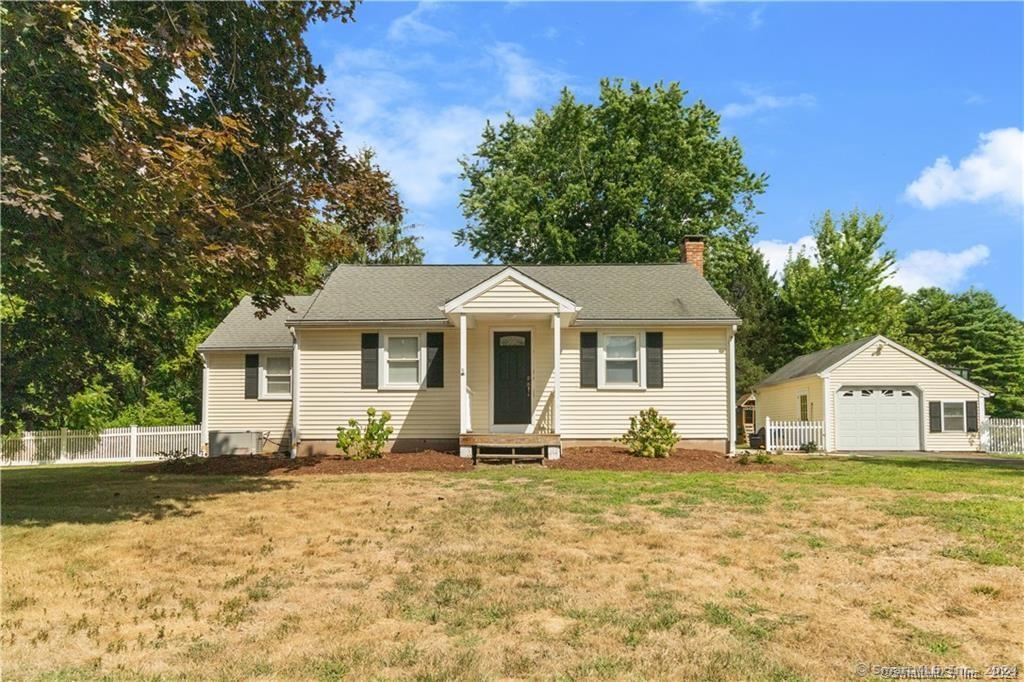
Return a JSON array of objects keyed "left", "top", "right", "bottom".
[{"left": 307, "top": 2, "right": 1024, "bottom": 316}]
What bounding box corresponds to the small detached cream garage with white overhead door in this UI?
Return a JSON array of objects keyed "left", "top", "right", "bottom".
[{"left": 755, "top": 335, "right": 992, "bottom": 451}]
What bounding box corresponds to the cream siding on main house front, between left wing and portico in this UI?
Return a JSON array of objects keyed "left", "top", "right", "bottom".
[{"left": 299, "top": 329, "right": 459, "bottom": 440}]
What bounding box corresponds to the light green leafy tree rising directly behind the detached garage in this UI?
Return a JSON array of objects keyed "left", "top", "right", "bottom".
[{"left": 780, "top": 210, "right": 903, "bottom": 354}]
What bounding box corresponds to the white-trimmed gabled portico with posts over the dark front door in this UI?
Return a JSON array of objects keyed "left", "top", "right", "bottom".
[{"left": 441, "top": 267, "right": 580, "bottom": 459}]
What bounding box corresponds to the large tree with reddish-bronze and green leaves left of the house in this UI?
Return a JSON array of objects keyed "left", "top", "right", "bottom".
[{"left": 0, "top": 2, "right": 402, "bottom": 429}]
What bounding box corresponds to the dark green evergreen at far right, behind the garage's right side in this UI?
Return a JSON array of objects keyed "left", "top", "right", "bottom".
[{"left": 901, "top": 288, "right": 1024, "bottom": 417}]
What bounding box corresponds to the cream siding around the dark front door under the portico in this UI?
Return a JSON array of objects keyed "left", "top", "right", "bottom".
[{"left": 468, "top": 319, "right": 565, "bottom": 433}]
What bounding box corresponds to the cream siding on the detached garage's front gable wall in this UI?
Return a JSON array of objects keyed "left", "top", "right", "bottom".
[{"left": 823, "top": 343, "right": 983, "bottom": 451}]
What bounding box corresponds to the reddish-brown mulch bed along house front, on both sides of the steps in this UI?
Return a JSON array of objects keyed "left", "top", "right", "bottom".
[{"left": 133, "top": 447, "right": 794, "bottom": 476}]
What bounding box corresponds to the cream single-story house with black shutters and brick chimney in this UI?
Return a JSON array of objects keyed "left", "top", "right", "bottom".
[{"left": 199, "top": 238, "right": 739, "bottom": 458}]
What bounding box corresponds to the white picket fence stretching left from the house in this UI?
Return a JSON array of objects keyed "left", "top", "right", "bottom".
[{"left": 0, "top": 424, "right": 203, "bottom": 467}]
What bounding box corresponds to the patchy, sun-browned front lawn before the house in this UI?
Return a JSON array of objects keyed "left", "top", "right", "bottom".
[{"left": 2, "top": 450, "right": 1024, "bottom": 680}]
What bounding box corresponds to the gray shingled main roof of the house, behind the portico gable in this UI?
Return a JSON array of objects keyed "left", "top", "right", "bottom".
[{"left": 292, "top": 263, "right": 737, "bottom": 324}]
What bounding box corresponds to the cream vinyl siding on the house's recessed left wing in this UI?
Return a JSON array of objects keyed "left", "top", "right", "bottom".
[{"left": 206, "top": 349, "right": 292, "bottom": 450}]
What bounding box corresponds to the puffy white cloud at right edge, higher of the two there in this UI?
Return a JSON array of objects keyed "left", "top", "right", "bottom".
[{"left": 905, "top": 128, "right": 1024, "bottom": 209}]
